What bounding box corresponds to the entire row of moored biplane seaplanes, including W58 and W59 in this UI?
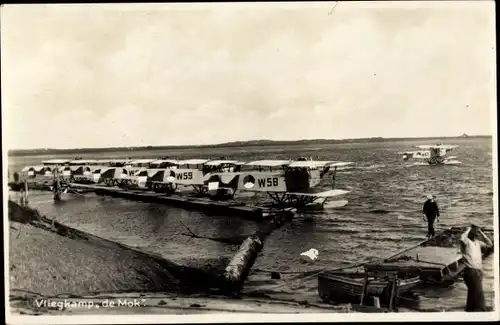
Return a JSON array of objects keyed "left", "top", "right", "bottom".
[{"left": 17, "top": 157, "right": 352, "bottom": 209}]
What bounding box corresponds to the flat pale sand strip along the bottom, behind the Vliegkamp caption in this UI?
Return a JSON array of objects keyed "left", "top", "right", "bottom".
[{"left": 11, "top": 293, "right": 351, "bottom": 315}]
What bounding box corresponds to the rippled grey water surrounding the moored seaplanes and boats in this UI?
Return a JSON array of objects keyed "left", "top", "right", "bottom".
[{"left": 9, "top": 139, "right": 494, "bottom": 310}]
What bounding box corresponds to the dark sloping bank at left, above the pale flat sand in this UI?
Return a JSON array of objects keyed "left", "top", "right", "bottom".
[{"left": 9, "top": 201, "right": 227, "bottom": 295}]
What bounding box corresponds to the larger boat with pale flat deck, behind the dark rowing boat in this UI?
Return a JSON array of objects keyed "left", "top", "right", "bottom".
[{"left": 364, "top": 228, "right": 493, "bottom": 286}]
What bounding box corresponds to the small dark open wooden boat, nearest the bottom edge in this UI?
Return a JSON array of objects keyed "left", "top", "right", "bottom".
[{"left": 318, "top": 271, "right": 421, "bottom": 305}]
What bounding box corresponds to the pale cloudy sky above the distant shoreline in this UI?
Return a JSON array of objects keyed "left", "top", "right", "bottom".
[{"left": 1, "top": 1, "right": 496, "bottom": 149}]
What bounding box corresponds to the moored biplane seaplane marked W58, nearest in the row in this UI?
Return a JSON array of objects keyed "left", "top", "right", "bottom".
[{"left": 207, "top": 159, "right": 352, "bottom": 211}]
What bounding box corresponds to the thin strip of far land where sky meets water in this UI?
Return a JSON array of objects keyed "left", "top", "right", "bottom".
[{"left": 8, "top": 133, "right": 493, "bottom": 153}]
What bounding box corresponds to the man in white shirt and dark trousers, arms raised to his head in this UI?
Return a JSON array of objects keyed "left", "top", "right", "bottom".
[{"left": 460, "top": 225, "right": 493, "bottom": 311}]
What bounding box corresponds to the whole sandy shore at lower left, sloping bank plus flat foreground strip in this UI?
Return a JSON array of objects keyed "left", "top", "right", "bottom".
[{"left": 9, "top": 199, "right": 348, "bottom": 315}]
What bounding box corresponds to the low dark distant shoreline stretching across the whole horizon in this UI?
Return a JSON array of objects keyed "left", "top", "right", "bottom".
[{"left": 8, "top": 135, "right": 492, "bottom": 157}]
